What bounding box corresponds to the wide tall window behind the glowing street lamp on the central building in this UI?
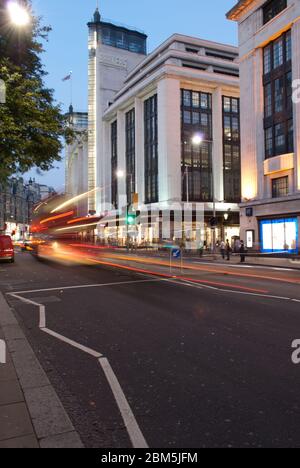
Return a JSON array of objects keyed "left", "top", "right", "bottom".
[{"left": 181, "top": 90, "right": 212, "bottom": 202}]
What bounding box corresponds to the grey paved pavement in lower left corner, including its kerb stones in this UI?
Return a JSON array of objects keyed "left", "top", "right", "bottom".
[{"left": 0, "top": 293, "right": 82, "bottom": 448}]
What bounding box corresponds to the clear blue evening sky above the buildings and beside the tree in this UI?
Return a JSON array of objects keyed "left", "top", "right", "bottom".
[{"left": 30, "top": 0, "right": 237, "bottom": 190}]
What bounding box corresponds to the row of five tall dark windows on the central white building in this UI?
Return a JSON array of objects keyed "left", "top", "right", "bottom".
[{"left": 111, "top": 89, "right": 241, "bottom": 206}]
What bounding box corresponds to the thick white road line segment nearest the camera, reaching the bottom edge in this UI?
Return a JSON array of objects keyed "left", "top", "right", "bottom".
[{"left": 99, "top": 358, "right": 148, "bottom": 448}]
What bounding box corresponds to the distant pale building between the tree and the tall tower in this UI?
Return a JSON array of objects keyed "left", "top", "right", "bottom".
[{"left": 65, "top": 105, "right": 88, "bottom": 216}]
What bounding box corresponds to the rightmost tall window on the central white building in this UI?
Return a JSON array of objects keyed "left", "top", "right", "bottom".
[{"left": 223, "top": 96, "right": 241, "bottom": 203}]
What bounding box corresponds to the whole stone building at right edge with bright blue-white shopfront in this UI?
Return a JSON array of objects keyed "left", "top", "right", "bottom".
[{"left": 227, "top": 0, "right": 300, "bottom": 253}]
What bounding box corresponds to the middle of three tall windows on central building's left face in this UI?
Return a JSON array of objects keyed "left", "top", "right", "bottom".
[{"left": 125, "top": 109, "right": 136, "bottom": 204}]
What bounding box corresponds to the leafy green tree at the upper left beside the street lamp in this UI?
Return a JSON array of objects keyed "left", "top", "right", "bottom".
[{"left": 0, "top": 0, "right": 72, "bottom": 181}]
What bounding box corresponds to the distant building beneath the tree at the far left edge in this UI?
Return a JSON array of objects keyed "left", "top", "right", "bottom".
[{"left": 0, "top": 177, "right": 55, "bottom": 241}]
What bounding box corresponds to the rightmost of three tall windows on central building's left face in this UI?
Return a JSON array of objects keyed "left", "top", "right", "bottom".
[{"left": 144, "top": 95, "right": 158, "bottom": 203}]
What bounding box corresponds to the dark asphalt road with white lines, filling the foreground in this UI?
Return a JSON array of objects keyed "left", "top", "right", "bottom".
[{"left": 0, "top": 254, "right": 300, "bottom": 448}]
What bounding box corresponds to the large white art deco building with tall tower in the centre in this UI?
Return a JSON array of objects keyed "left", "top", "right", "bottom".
[{"left": 66, "top": 10, "right": 240, "bottom": 244}]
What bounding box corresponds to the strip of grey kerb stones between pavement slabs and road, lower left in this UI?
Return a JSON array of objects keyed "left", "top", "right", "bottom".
[{"left": 0, "top": 292, "right": 84, "bottom": 448}]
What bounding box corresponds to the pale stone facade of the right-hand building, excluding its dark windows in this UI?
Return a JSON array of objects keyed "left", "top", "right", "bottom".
[{"left": 228, "top": 0, "right": 300, "bottom": 251}]
